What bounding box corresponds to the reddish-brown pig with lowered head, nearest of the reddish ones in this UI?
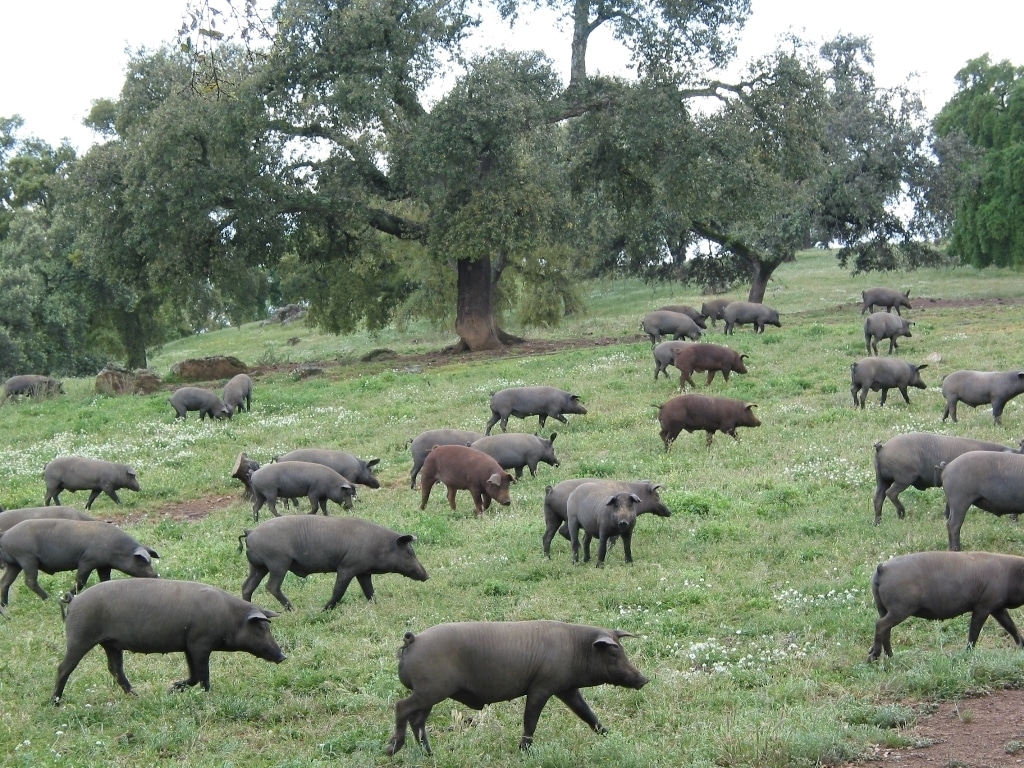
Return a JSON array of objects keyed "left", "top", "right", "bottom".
[{"left": 420, "top": 445, "right": 515, "bottom": 517}]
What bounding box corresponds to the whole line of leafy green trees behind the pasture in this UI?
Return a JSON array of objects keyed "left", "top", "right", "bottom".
[{"left": 0, "top": 0, "right": 1024, "bottom": 375}]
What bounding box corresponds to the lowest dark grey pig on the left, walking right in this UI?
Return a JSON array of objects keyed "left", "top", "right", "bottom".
[{"left": 51, "top": 579, "right": 287, "bottom": 705}]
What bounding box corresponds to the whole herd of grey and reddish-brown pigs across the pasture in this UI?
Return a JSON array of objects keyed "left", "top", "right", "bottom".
[{"left": 6, "top": 288, "right": 1024, "bottom": 755}]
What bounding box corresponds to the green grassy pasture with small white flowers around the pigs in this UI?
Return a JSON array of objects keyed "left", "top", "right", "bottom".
[{"left": 6, "top": 251, "right": 1024, "bottom": 768}]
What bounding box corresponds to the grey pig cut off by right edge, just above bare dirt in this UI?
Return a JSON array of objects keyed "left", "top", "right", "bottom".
[{"left": 867, "top": 552, "right": 1024, "bottom": 662}]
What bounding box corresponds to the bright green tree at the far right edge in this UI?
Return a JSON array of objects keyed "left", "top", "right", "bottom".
[{"left": 934, "top": 54, "right": 1024, "bottom": 267}]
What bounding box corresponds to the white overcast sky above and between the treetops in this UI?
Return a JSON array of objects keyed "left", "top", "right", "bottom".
[{"left": 0, "top": 0, "right": 1024, "bottom": 150}]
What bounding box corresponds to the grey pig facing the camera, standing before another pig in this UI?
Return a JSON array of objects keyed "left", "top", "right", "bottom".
[{"left": 565, "top": 481, "right": 640, "bottom": 567}]
